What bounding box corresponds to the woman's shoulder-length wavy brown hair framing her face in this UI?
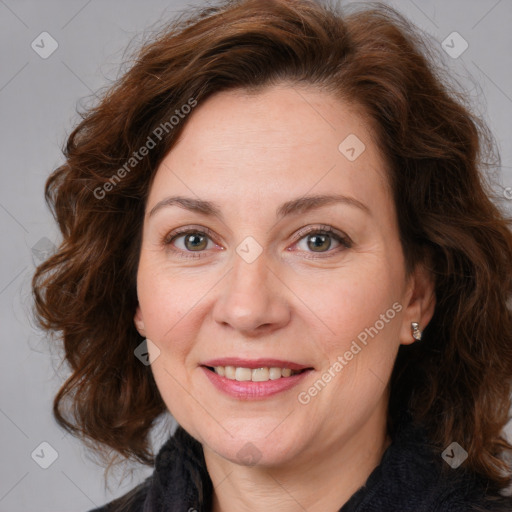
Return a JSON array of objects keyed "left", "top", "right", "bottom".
[{"left": 33, "top": 0, "right": 512, "bottom": 489}]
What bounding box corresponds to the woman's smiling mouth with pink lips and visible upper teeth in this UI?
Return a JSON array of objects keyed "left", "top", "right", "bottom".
[{"left": 201, "top": 358, "right": 313, "bottom": 399}]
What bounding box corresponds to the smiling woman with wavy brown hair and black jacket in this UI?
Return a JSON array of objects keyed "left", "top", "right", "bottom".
[{"left": 34, "top": 0, "right": 512, "bottom": 512}]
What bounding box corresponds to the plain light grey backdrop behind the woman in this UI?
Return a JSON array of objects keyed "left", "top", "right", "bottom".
[{"left": 0, "top": 0, "right": 512, "bottom": 512}]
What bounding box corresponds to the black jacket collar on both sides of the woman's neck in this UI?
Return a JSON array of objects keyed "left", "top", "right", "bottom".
[{"left": 97, "top": 413, "right": 512, "bottom": 512}]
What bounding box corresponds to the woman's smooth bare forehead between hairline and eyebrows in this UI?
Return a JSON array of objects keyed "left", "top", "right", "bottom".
[{"left": 148, "top": 85, "right": 390, "bottom": 218}]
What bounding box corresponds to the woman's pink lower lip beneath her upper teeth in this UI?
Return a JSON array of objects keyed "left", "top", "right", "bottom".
[{"left": 201, "top": 366, "right": 311, "bottom": 400}]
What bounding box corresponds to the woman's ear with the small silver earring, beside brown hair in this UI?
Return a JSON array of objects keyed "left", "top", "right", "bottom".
[{"left": 400, "top": 264, "right": 436, "bottom": 345}]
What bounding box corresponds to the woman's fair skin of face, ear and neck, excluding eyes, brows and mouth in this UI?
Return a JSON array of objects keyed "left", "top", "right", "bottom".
[{"left": 135, "top": 84, "right": 435, "bottom": 512}]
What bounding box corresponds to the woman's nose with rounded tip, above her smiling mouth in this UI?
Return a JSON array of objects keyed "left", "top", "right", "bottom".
[{"left": 213, "top": 248, "right": 290, "bottom": 337}]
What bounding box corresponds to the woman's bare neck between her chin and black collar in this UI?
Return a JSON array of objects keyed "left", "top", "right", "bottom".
[{"left": 204, "top": 402, "right": 391, "bottom": 512}]
